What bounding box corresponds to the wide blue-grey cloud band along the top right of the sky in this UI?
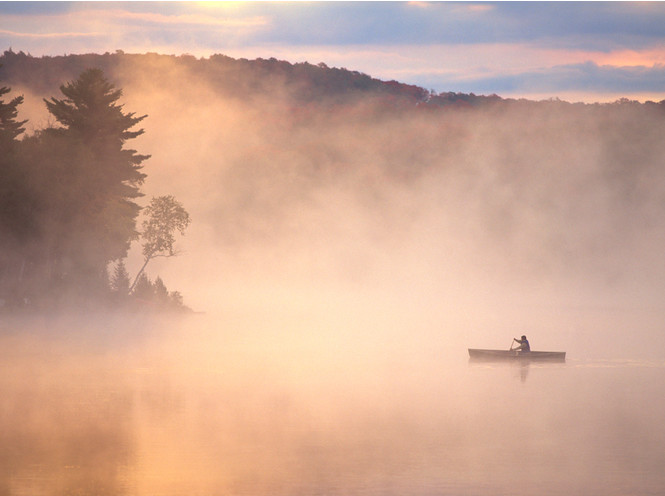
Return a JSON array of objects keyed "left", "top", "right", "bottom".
[{"left": 243, "top": 2, "right": 665, "bottom": 51}]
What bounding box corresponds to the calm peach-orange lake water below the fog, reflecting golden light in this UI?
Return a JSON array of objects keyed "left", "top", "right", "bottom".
[{"left": 0, "top": 315, "right": 665, "bottom": 496}]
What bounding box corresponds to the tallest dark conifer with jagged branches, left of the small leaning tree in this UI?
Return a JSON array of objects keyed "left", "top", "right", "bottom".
[{"left": 37, "top": 69, "right": 148, "bottom": 291}]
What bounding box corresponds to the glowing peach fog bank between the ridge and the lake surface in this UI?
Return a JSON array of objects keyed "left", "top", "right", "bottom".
[{"left": 9, "top": 53, "right": 665, "bottom": 353}]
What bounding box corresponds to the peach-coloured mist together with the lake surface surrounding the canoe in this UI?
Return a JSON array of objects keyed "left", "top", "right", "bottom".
[{"left": 5, "top": 55, "right": 665, "bottom": 496}]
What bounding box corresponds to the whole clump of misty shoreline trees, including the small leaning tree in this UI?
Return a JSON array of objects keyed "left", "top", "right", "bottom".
[{"left": 0, "top": 69, "right": 190, "bottom": 309}]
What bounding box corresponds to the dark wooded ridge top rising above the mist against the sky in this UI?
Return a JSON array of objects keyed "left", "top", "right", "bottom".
[{"left": 0, "top": 50, "right": 504, "bottom": 106}]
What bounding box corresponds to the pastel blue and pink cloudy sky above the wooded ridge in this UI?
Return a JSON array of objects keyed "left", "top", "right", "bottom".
[{"left": 0, "top": 1, "right": 665, "bottom": 102}]
